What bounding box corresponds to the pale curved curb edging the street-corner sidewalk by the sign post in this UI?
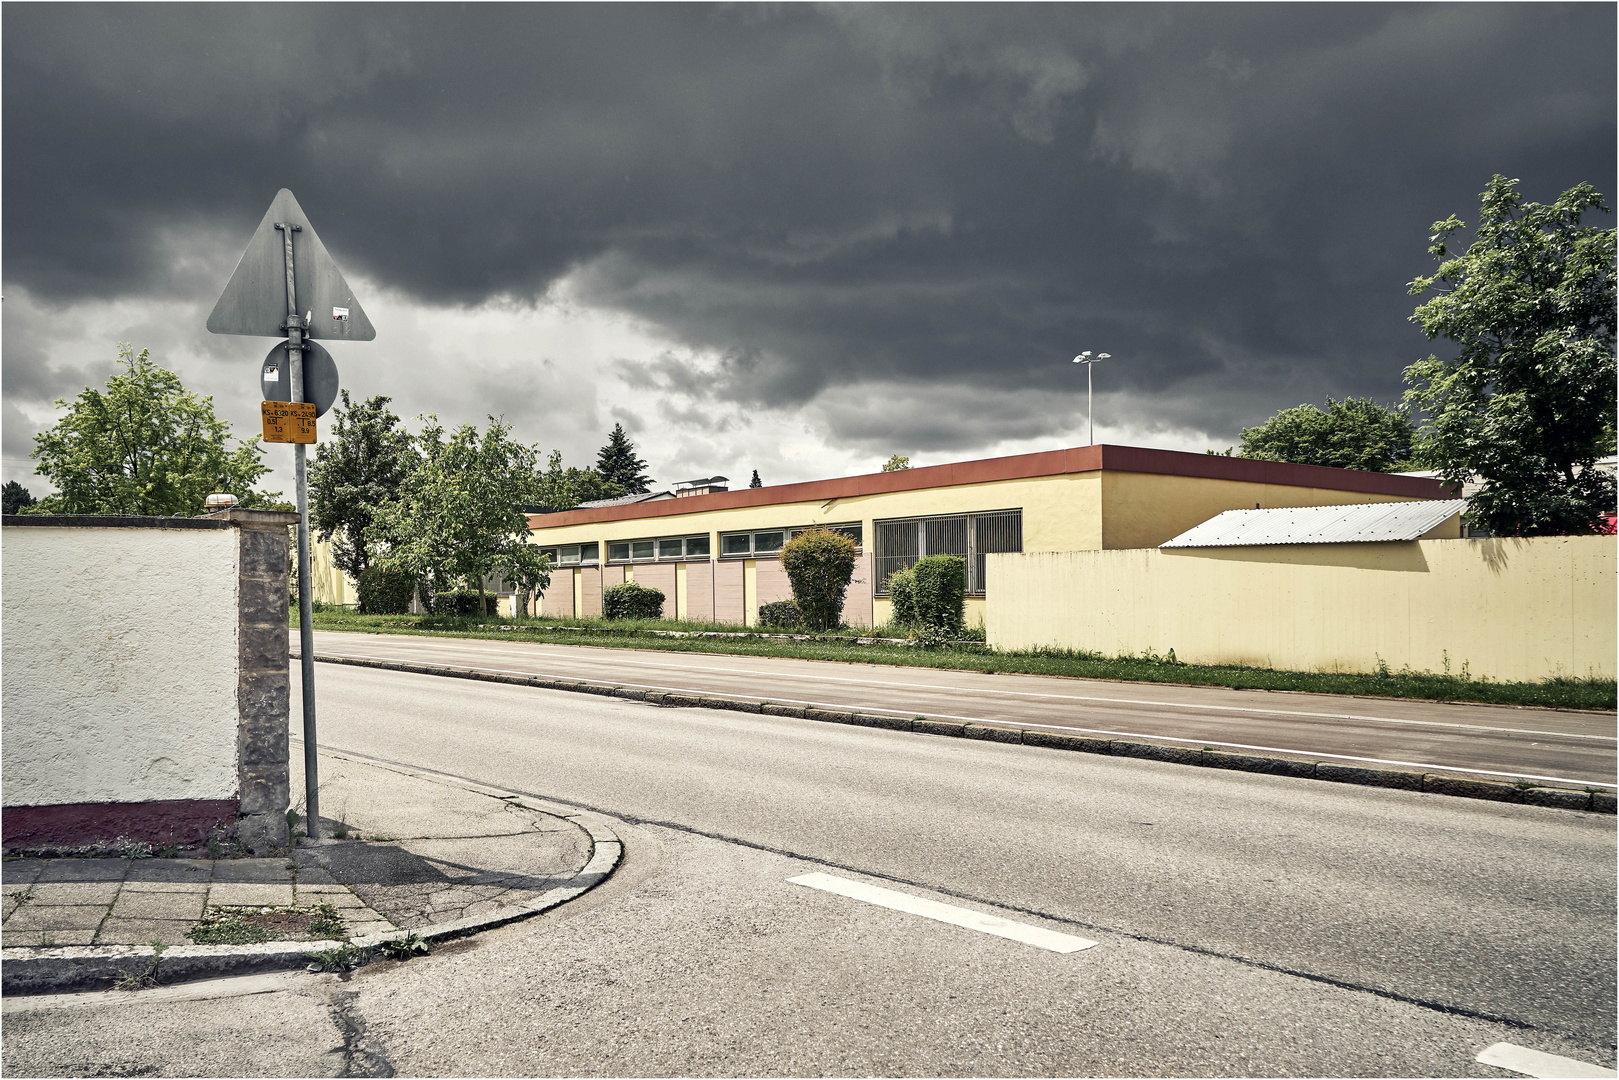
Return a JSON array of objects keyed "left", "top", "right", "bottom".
[{"left": 0, "top": 761, "right": 623, "bottom": 996}]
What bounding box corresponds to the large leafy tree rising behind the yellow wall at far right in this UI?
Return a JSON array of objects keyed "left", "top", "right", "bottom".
[{"left": 1405, "top": 175, "right": 1616, "bottom": 536}]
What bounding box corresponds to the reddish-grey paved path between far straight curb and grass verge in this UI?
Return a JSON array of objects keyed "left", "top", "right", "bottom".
[{"left": 305, "top": 631, "right": 1619, "bottom": 787}]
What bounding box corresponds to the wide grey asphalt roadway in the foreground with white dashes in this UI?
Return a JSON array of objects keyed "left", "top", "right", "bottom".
[{"left": 3, "top": 665, "right": 1616, "bottom": 1077}]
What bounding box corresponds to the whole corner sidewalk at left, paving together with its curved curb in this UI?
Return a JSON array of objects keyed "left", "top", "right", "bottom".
[{"left": 0, "top": 753, "right": 622, "bottom": 994}]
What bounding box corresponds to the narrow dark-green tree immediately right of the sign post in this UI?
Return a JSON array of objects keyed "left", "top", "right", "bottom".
[{"left": 309, "top": 390, "right": 416, "bottom": 586}]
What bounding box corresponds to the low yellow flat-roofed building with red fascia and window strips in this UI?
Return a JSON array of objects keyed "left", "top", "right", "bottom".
[{"left": 529, "top": 445, "right": 1460, "bottom": 627}]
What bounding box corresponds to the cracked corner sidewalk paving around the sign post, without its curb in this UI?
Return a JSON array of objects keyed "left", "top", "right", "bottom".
[{"left": 0, "top": 753, "right": 593, "bottom": 947}]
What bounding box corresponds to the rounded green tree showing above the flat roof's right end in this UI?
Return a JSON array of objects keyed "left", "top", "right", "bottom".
[{"left": 1240, "top": 398, "right": 1417, "bottom": 473}]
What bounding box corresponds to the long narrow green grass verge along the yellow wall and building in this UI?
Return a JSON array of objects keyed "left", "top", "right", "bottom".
[{"left": 291, "top": 610, "right": 1616, "bottom": 709}]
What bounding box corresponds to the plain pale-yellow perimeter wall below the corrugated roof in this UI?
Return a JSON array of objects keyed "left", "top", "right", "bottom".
[{"left": 984, "top": 536, "right": 1619, "bottom": 682}]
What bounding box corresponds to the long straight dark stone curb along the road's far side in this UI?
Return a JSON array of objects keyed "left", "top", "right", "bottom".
[{"left": 305, "top": 653, "right": 1619, "bottom": 814}]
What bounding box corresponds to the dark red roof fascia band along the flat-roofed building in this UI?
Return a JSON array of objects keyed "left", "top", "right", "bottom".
[{"left": 528, "top": 445, "right": 1449, "bottom": 529}]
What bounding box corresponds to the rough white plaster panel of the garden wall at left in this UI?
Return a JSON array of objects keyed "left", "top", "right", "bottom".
[{"left": 0, "top": 528, "right": 236, "bottom": 806}]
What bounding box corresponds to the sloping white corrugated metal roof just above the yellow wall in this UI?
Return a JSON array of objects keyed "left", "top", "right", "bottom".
[{"left": 1159, "top": 499, "right": 1467, "bottom": 547}]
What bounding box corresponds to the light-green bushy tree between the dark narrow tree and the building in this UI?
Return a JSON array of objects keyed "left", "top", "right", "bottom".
[{"left": 366, "top": 416, "right": 550, "bottom": 612}]
